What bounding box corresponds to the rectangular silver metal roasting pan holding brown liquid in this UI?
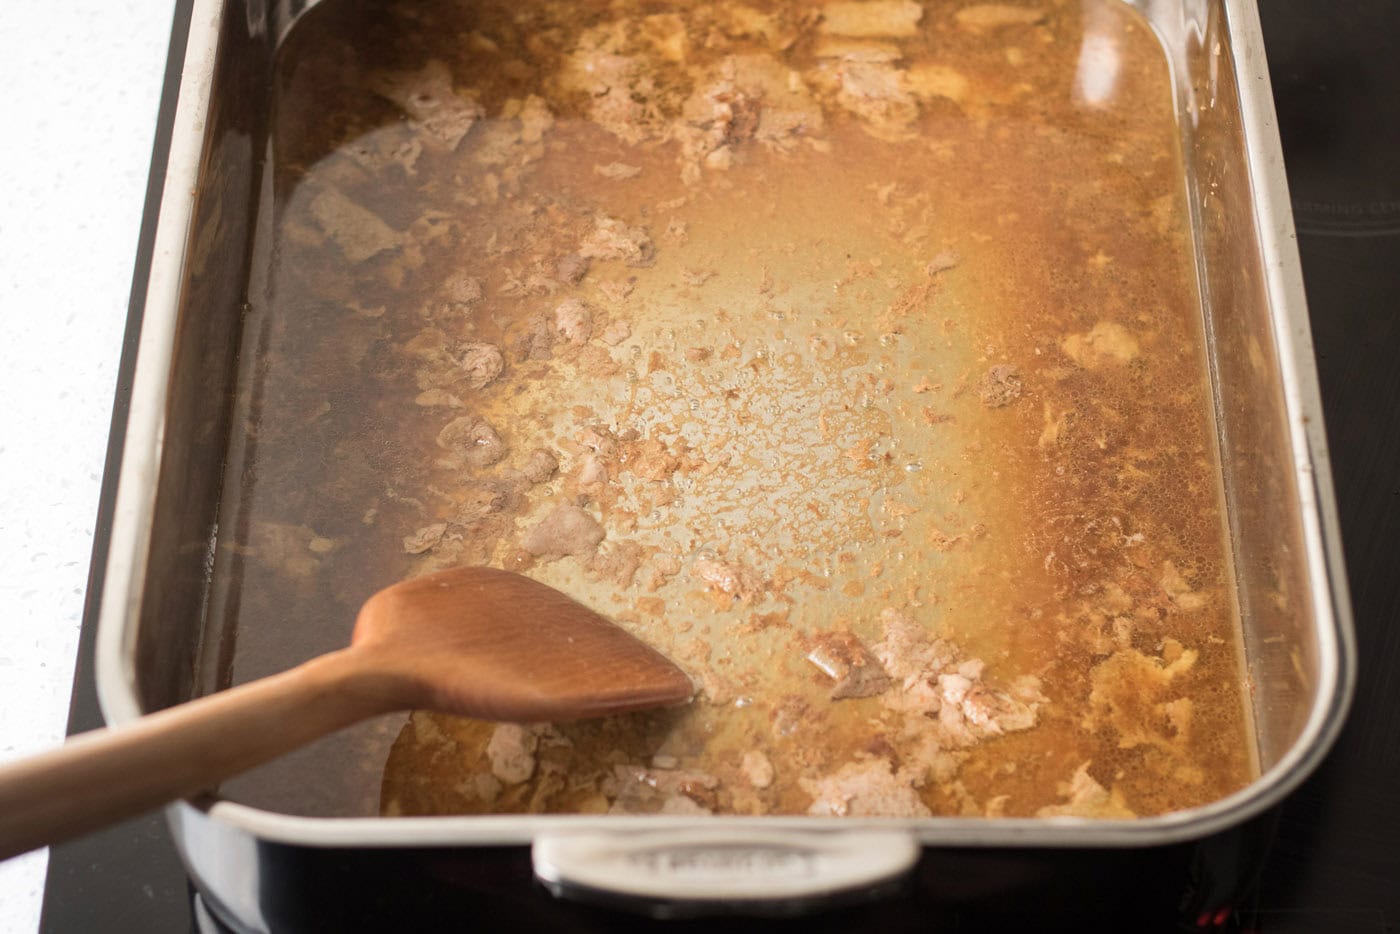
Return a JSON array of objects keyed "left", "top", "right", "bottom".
[{"left": 97, "top": 0, "right": 1355, "bottom": 930}]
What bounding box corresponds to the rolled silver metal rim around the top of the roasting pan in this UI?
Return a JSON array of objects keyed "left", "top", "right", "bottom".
[{"left": 97, "top": 0, "right": 1355, "bottom": 847}]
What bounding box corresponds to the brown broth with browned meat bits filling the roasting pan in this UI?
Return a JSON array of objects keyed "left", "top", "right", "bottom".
[{"left": 211, "top": 0, "right": 1253, "bottom": 816}]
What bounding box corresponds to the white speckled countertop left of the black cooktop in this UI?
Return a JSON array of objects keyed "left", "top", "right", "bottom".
[{"left": 0, "top": 0, "right": 174, "bottom": 934}]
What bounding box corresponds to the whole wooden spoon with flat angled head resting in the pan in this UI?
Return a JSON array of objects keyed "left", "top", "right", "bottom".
[{"left": 0, "top": 567, "right": 694, "bottom": 860}]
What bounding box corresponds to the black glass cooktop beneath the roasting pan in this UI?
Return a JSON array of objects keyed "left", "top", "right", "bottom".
[{"left": 42, "top": 0, "right": 1400, "bottom": 934}]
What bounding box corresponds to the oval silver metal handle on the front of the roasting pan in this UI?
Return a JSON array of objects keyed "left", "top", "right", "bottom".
[{"left": 532, "top": 828, "right": 920, "bottom": 917}]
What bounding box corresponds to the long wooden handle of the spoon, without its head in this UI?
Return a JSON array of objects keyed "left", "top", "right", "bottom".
[{"left": 0, "top": 650, "right": 400, "bottom": 860}]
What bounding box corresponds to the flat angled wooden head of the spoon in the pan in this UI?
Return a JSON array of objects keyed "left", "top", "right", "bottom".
[{"left": 351, "top": 567, "right": 694, "bottom": 721}]
